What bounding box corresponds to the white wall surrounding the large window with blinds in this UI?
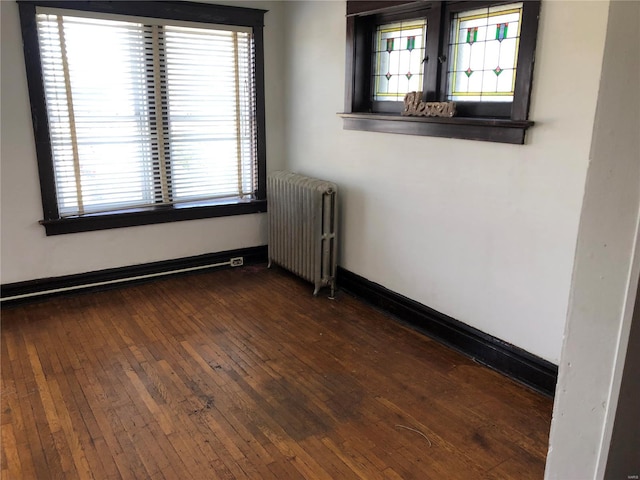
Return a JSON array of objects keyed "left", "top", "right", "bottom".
[{"left": 0, "top": 1, "right": 284, "bottom": 284}]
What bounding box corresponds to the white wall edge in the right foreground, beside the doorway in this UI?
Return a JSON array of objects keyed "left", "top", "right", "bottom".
[{"left": 546, "top": 1, "right": 640, "bottom": 480}]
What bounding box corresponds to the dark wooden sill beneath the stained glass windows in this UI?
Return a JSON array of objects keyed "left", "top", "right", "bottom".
[{"left": 338, "top": 113, "right": 533, "bottom": 145}]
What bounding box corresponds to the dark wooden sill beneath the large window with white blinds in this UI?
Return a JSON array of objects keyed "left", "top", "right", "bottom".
[{"left": 40, "top": 200, "right": 267, "bottom": 236}]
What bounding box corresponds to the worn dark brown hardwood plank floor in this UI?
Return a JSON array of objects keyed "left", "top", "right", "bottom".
[{"left": 1, "top": 267, "right": 552, "bottom": 480}]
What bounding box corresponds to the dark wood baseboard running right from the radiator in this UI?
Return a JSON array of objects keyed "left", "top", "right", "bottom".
[{"left": 337, "top": 267, "right": 558, "bottom": 397}]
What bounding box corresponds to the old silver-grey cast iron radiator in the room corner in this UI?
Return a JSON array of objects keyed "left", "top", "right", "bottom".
[{"left": 267, "top": 171, "right": 338, "bottom": 297}]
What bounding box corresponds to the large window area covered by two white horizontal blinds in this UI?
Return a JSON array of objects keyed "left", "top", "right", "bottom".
[{"left": 36, "top": 9, "right": 258, "bottom": 218}]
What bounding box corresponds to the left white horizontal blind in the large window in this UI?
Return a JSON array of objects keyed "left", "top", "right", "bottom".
[{"left": 37, "top": 14, "right": 154, "bottom": 216}]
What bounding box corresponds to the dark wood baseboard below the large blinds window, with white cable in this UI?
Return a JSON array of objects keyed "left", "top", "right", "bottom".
[{"left": 0, "top": 245, "right": 267, "bottom": 308}]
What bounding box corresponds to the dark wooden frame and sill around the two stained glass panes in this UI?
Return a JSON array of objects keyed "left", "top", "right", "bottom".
[{"left": 340, "top": 0, "right": 540, "bottom": 144}]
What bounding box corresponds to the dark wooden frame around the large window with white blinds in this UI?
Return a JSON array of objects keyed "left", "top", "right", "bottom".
[{"left": 18, "top": 0, "right": 267, "bottom": 235}]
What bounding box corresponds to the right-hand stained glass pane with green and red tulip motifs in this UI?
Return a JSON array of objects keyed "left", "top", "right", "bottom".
[{"left": 447, "top": 3, "right": 523, "bottom": 102}]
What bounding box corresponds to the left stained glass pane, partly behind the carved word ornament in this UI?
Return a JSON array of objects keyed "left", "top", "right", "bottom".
[{"left": 373, "top": 20, "right": 427, "bottom": 101}]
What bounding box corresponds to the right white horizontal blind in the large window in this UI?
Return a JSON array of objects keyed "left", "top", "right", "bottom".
[{"left": 164, "top": 26, "right": 256, "bottom": 202}]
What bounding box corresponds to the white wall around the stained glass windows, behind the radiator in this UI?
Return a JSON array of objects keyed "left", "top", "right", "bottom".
[{"left": 286, "top": 1, "right": 608, "bottom": 363}]
